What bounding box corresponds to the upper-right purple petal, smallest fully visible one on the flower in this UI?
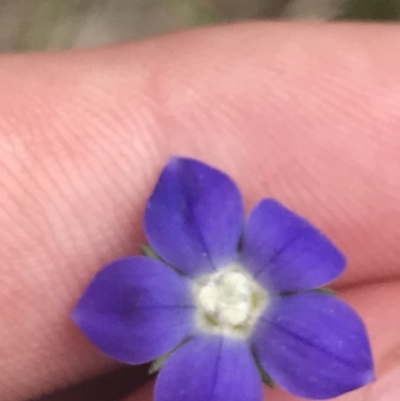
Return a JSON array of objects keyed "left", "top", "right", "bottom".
[{"left": 241, "top": 199, "right": 346, "bottom": 292}]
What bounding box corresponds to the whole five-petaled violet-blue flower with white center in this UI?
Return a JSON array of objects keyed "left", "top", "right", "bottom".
[{"left": 73, "top": 158, "right": 374, "bottom": 401}]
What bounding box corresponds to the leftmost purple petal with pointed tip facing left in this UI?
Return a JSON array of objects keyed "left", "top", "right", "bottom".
[{"left": 72, "top": 257, "right": 194, "bottom": 364}]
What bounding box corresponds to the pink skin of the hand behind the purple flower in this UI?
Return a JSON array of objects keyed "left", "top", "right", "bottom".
[{"left": 0, "top": 23, "right": 400, "bottom": 401}]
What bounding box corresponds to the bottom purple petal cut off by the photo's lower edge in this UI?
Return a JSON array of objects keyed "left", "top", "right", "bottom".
[{"left": 155, "top": 336, "right": 263, "bottom": 401}]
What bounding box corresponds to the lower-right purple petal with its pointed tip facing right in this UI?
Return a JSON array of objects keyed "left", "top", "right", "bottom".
[{"left": 252, "top": 293, "right": 374, "bottom": 399}]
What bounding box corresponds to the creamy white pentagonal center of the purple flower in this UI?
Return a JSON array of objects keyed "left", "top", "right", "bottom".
[{"left": 194, "top": 265, "right": 268, "bottom": 337}]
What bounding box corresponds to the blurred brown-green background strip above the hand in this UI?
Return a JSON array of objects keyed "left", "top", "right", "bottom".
[{"left": 0, "top": 0, "right": 400, "bottom": 52}]
